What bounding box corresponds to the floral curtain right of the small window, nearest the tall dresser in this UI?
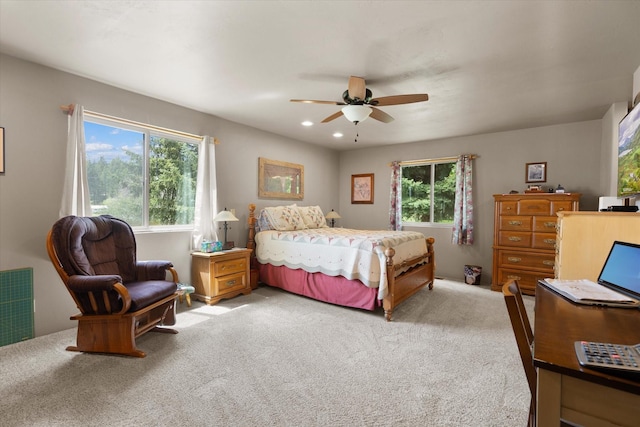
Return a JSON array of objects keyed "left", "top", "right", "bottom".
[{"left": 451, "top": 154, "right": 473, "bottom": 245}]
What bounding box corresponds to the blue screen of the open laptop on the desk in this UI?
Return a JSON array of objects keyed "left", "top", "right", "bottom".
[{"left": 598, "top": 241, "right": 640, "bottom": 298}]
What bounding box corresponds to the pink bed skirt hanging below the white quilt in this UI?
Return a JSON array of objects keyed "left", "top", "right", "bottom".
[{"left": 259, "top": 264, "right": 380, "bottom": 310}]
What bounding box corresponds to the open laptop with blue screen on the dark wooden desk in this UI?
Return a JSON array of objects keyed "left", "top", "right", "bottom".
[{"left": 540, "top": 240, "right": 640, "bottom": 308}]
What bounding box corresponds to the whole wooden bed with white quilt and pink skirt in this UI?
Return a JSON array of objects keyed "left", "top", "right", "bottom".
[{"left": 247, "top": 204, "right": 435, "bottom": 321}]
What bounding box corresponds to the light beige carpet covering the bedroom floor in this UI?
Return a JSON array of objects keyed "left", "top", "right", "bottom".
[{"left": 0, "top": 280, "right": 533, "bottom": 426}]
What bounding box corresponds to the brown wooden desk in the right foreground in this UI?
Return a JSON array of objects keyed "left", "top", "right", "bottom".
[{"left": 533, "top": 284, "right": 640, "bottom": 426}]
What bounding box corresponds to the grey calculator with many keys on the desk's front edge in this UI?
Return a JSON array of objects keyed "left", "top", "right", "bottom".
[{"left": 575, "top": 341, "right": 640, "bottom": 373}]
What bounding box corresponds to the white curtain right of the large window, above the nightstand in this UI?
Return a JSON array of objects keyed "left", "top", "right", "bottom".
[{"left": 191, "top": 136, "right": 218, "bottom": 250}]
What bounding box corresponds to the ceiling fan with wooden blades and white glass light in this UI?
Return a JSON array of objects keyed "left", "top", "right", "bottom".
[{"left": 291, "top": 76, "right": 429, "bottom": 125}]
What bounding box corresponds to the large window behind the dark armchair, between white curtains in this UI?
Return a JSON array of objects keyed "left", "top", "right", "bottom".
[{"left": 84, "top": 115, "right": 199, "bottom": 228}]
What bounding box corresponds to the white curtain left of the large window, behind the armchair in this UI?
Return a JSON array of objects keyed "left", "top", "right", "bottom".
[{"left": 60, "top": 105, "right": 92, "bottom": 218}]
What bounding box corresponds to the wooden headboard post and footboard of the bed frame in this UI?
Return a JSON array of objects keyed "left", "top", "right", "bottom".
[{"left": 247, "top": 204, "right": 435, "bottom": 321}]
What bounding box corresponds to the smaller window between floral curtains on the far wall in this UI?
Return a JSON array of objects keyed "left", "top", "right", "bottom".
[{"left": 401, "top": 161, "right": 456, "bottom": 224}]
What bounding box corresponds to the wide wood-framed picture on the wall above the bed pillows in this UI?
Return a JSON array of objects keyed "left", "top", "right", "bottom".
[{"left": 258, "top": 157, "right": 304, "bottom": 200}]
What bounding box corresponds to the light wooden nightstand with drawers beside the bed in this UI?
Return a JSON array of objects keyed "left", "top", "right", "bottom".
[{"left": 191, "top": 248, "right": 251, "bottom": 305}]
